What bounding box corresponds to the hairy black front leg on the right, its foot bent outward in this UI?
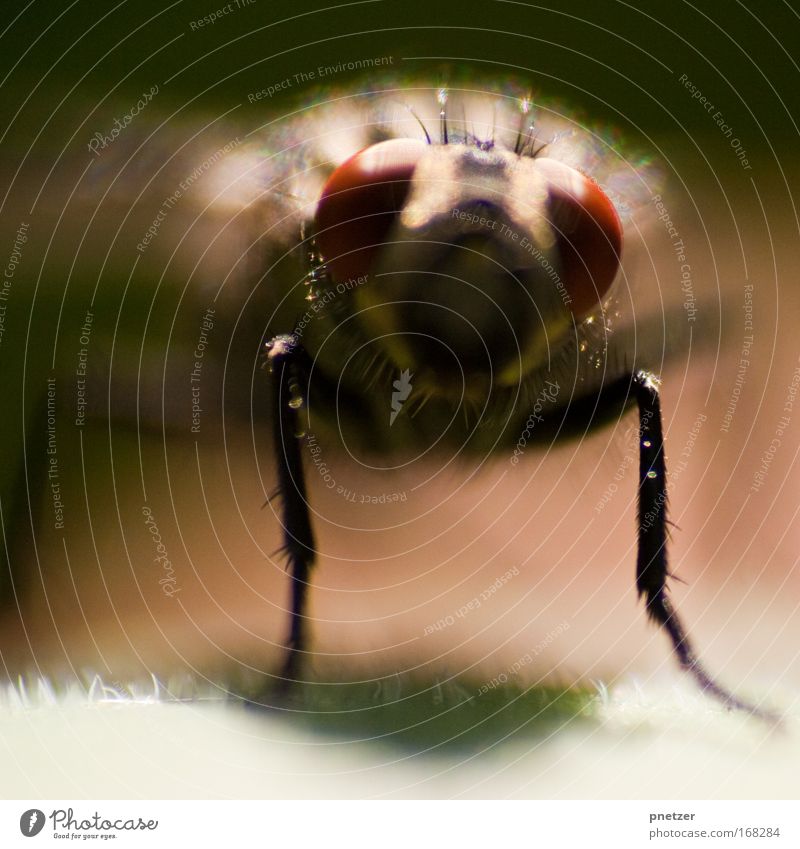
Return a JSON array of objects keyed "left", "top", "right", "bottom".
[{"left": 630, "top": 372, "right": 773, "bottom": 718}]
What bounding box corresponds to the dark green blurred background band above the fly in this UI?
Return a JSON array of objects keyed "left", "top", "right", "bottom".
[{"left": 3, "top": 0, "right": 798, "bottom": 156}]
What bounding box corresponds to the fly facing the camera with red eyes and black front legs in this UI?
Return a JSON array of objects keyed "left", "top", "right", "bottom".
[{"left": 266, "top": 83, "right": 766, "bottom": 716}]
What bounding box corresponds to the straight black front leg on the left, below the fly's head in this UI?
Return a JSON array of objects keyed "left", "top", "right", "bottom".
[{"left": 267, "top": 334, "right": 315, "bottom": 690}]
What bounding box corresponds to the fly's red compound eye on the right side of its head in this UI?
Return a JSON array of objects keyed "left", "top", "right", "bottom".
[{"left": 536, "top": 157, "right": 622, "bottom": 318}]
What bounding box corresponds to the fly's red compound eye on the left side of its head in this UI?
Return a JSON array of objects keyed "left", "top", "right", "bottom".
[{"left": 315, "top": 139, "right": 427, "bottom": 280}]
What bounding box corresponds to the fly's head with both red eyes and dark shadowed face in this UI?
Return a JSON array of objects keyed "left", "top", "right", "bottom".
[{"left": 296, "top": 116, "right": 622, "bottom": 450}]
